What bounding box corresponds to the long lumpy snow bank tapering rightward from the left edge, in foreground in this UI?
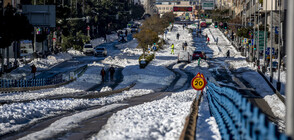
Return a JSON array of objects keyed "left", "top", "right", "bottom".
[{"left": 0, "top": 89, "right": 153, "bottom": 135}]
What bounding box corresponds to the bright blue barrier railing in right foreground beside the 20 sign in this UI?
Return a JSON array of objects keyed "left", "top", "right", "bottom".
[{"left": 206, "top": 81, "right": 290, "bottom": 140}]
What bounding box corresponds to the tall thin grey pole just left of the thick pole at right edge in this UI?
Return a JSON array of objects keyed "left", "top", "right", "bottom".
[{"left": 270, "top": 0, "right": 274, "bottom": 82}]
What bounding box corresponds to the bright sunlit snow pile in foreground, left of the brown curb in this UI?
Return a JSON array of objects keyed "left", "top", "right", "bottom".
[{"left": 92, "top": 90, "right": 197, "bottom": 140}]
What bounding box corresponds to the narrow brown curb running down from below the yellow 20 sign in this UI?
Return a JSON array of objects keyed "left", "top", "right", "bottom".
[{"left": 179, "top": 91, "right": 203, "bottom": 140}]
